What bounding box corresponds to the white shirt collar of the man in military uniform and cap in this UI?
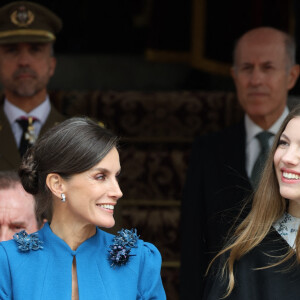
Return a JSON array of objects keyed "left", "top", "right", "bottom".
[{"left": 3, "top": 95, "right": 51, "bottom": 148}]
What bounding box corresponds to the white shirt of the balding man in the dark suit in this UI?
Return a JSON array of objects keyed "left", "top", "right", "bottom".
[{"left": 245, "top": 107, "right": 289, "bottom": 178}]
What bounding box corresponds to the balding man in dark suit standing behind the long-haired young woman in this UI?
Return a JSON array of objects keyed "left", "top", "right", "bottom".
[{"left": 181, "top": 27, "right": 299, "bottom": 300}]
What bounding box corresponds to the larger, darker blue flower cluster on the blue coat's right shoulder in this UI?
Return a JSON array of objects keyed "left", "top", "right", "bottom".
[{"left": 108, "top": 229, "right": 139, "bottom": 267}]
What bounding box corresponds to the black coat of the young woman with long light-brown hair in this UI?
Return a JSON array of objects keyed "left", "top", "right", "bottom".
[{"left": 203, "top": 230, "right": 300, "bottom": 300}]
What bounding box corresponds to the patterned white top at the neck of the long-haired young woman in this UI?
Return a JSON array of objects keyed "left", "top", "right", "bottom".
[{"left": 273, "top": 212, "right": 300, "bottom": 249}]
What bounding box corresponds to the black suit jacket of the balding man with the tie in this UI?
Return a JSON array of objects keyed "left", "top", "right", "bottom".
[{"left": 180, "top": 122, "right": 252, "bottom": 300}]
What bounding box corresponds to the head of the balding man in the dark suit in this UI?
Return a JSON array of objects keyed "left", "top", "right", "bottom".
[{"left": 231, "top": 27, "right": 299, "bottom": 130}]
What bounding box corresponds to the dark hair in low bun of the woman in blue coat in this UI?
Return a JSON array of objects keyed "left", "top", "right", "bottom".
[{"left": 19, "top": 118, "right": 118, "bottom": 221}]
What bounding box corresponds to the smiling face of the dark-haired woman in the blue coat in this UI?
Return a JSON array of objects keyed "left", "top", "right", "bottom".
[{"left": 60, "top": 148, "right": 122, "bottom": 228}]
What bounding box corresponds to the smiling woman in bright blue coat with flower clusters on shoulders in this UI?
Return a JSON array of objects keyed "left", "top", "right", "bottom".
[{"left": 0, "top": 118, "right": 166, "bottom": 300}]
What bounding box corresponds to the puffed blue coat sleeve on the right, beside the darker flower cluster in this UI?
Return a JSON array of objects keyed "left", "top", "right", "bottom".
[{"left": 139, "top": 242, "right": 166, "bottom": 300}]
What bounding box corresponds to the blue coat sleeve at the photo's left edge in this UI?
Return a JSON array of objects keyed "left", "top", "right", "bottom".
[{"left": 0, "top": 244, "right": 12, "bottom": 300}]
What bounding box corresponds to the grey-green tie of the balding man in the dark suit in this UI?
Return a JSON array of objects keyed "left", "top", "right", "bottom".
[{"left": 250, "top": 131, "right": 273, "bottom": 188}]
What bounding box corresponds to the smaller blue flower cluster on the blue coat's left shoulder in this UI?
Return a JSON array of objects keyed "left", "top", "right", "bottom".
[{"left": 13, "top": 230, "right": 43, "bottom": 252}]
